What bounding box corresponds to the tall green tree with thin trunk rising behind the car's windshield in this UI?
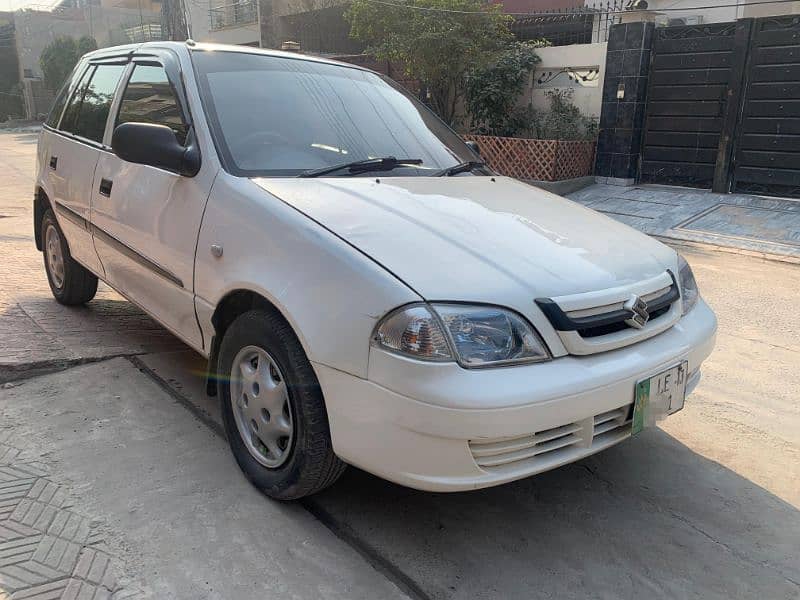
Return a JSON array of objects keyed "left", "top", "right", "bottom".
[{"left": 345, "top": 0, "right": 512, "bottom": 125}]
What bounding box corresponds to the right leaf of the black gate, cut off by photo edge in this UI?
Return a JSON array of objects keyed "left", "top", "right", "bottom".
[{"left": 732, "top": 16, "right": 800, "bottom": 198}]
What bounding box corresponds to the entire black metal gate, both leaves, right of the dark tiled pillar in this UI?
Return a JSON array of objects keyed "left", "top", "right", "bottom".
[{"left": 639, "top": 16, "right": 800, "bottom": 197}]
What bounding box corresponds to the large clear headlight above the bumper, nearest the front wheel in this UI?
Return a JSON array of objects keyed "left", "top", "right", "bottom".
[{"left": 374, "top": 304, "right": 550, "bottom": 368}]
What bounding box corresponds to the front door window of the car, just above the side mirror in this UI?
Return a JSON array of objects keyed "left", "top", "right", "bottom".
[{"left": 117, "top": 65, "right": 186, "bottom": 144}]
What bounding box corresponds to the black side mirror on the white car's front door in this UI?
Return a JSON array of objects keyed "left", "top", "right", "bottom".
[{"left": 111, "top": 123, "right": 200, "bottom": 177}]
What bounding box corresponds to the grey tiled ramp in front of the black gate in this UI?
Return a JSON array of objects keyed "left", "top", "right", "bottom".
[{"left": 568, "top": 184, "right": 800, "bottom": 259}]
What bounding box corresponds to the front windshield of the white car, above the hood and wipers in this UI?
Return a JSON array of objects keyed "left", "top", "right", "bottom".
[{"left": 192, "top": 51, "right": 474, "bottom": 177}]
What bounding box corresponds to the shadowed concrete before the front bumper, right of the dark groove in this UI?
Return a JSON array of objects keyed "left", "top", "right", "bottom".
[{"left": 311, "top": 429, "right": 800, "bottom": 599}]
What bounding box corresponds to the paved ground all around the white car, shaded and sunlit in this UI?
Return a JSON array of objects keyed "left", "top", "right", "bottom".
[{"left": 0, "top": 134, "right": 800, "bottom": 600}]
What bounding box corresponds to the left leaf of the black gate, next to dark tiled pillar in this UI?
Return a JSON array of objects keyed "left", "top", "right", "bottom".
[{"left": 639, "top": 23, "right": 736, "bottom": 188}]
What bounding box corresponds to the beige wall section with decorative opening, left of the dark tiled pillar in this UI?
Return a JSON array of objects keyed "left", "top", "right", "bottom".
[{"left": 520, "top": 42, "right": 606, "bottom": 117}]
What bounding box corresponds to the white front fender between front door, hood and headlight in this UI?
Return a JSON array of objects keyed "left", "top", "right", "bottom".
[{"left": 195, "top": 173, "right": 421, "bottom": 377}]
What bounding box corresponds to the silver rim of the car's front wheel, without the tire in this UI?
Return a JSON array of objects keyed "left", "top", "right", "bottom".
[{"left": 230, "top": 346, "right": 294, "bottom": 469}]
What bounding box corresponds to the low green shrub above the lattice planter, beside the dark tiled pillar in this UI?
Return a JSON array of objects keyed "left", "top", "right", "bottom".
[{"left": 517, "top": 89, "right": 598, "bottom": 140}]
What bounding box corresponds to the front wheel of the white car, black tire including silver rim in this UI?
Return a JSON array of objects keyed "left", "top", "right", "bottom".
[{"left": 217, "top": 310, "right": 347, "bottom": 500}]
